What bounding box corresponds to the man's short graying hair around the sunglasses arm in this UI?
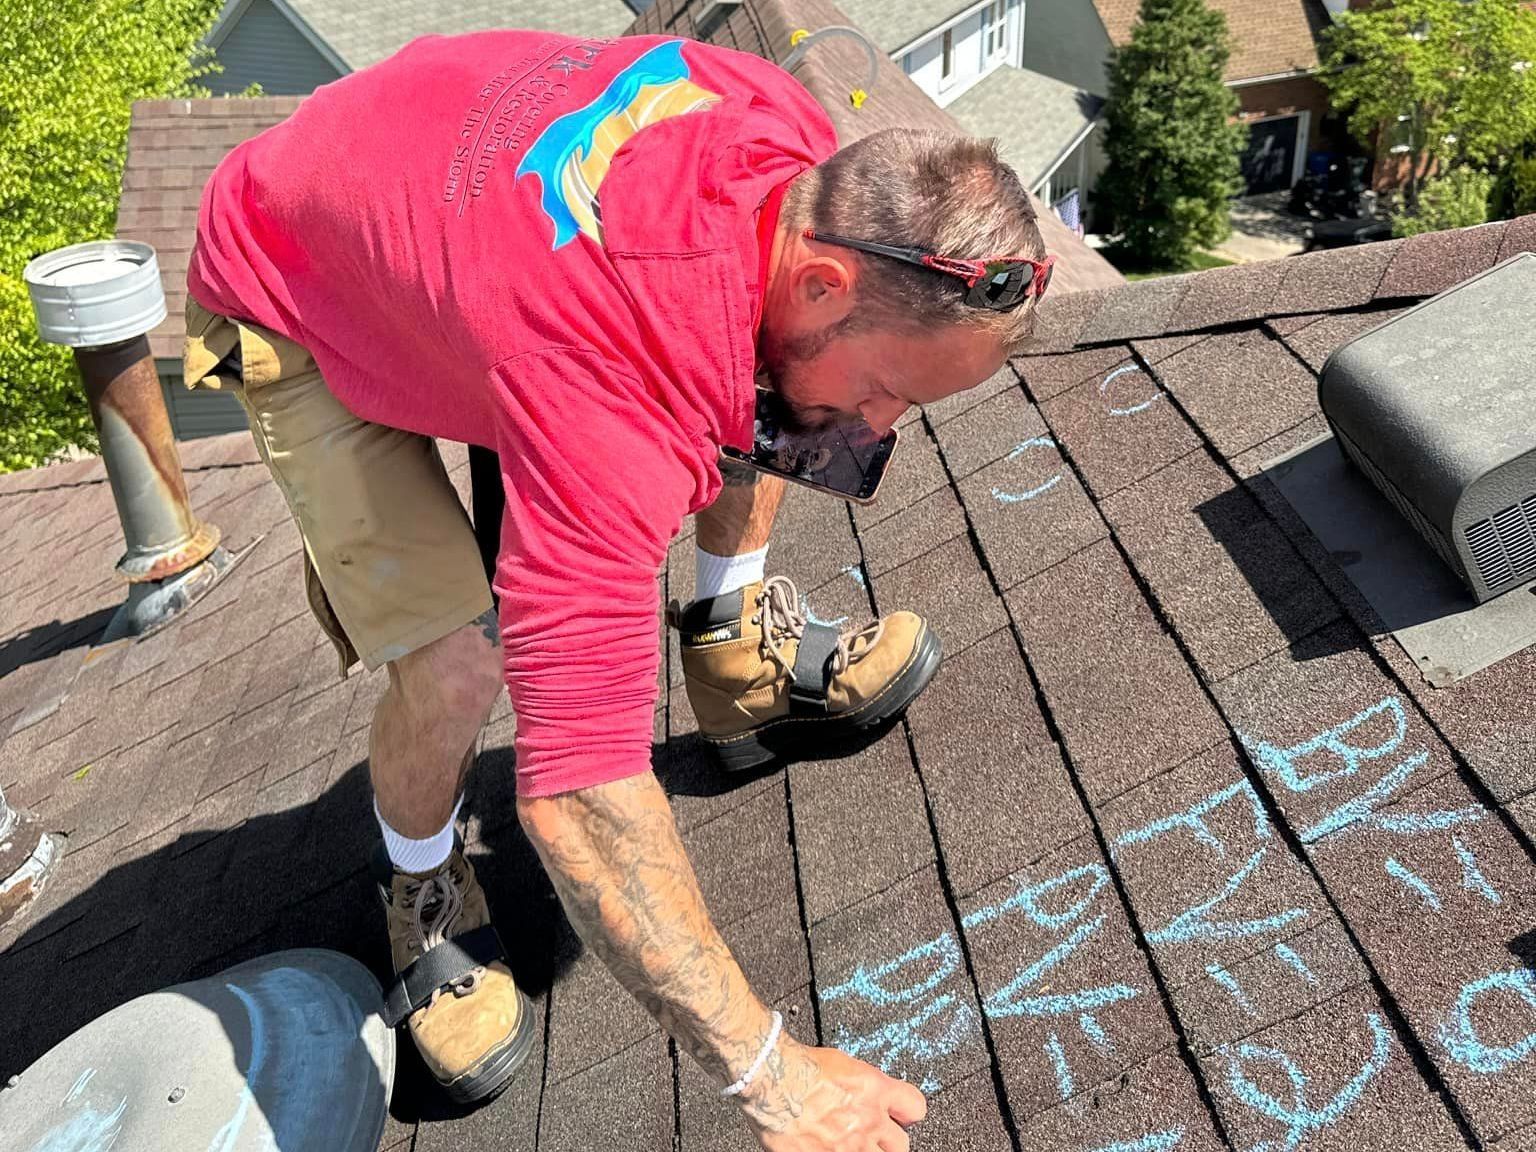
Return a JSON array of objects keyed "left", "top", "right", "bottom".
[{"left": 785, "top": 127, "right": 1044, "bottom": 350}]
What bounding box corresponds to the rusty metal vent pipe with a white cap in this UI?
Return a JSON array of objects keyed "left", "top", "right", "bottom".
[{"left": 22, "top": 240, "right": 235, "bottom": 644}]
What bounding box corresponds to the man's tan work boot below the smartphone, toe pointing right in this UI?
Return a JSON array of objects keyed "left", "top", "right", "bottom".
[{"left": 670, "top": 576, "right": 943, "bottom": 770}]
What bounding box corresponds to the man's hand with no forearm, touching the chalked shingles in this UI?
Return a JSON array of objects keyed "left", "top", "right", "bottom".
[{"left": 742, "top": 1037, "right": 928, "bottom": 1152}]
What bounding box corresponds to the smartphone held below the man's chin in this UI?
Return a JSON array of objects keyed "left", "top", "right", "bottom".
[{"left": 720, "top": 389, "right": 897, "bottom": 504}]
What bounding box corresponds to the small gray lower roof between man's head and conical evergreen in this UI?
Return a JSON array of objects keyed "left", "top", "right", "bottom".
[{"left": 945, "top": 65, "right": 1104, "bottom": 187}]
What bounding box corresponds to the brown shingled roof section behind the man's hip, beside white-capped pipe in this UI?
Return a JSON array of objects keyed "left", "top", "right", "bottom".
[{"left": 117, "top": 97, "right": 303, "bottom": 359}]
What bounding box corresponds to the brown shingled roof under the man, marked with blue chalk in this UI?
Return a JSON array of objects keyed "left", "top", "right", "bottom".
[{"left": 0, "top": 217, "right": 1536, "bottom": 1152}]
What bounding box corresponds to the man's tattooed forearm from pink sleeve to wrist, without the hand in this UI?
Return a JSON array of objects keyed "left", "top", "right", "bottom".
[{"left": 518, "top": 773, "right": 771, "bottom": 1083}]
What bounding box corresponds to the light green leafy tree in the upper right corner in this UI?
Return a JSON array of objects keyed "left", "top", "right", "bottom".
[{"left": 1322, "top": 0, "right": 1536, "bottom": 212}]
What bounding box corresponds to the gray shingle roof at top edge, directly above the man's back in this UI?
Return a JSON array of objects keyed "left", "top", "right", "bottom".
[{"left": 209, "top": 0, "right": 634, "bottom": 71}]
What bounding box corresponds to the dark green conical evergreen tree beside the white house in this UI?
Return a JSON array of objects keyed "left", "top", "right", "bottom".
[{"left": 1095, "top": 0, "right": 1246, "bottom": 267}]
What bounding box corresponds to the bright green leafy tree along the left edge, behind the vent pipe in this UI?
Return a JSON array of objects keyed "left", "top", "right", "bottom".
[{"left": 0, "top": 0, "right": 220, "bottom": 472}]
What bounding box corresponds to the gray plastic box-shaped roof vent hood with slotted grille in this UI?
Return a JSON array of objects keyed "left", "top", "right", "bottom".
[{"left": 1319, "top": 253, "right": 1536, "bottom": 602}]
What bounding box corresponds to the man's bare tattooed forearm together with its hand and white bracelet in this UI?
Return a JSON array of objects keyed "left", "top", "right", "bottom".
[{"left": 518, "top": 773, "right": 923, "bottom": 1152}]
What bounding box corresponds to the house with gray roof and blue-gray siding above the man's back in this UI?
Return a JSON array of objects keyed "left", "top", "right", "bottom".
[{"left": 207, "top": 0, "right": 648, "bottom": 95}]
